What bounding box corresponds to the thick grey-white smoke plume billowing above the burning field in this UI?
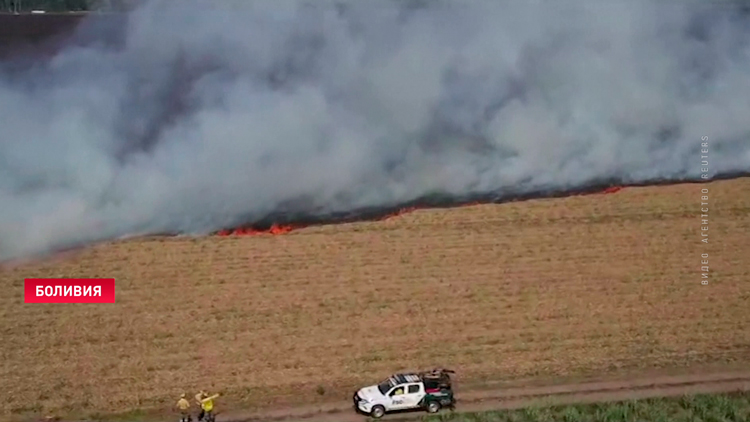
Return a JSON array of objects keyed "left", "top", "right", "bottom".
[{"left": 0, "top": 0, "right": 750, "bottom": 259}]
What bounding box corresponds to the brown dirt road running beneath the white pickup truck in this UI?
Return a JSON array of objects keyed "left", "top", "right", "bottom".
[{"left": 226, "top": 371, "right": 750, "bottom": 422}]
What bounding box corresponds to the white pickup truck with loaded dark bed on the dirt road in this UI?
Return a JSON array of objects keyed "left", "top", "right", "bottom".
[{"left": 352, "top": 369, "right": 456, "bottom": 419}]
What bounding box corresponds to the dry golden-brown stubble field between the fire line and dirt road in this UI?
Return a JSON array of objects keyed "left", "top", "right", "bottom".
[{"left": 0, "top": 179, "right": 750, "bottom": 419}]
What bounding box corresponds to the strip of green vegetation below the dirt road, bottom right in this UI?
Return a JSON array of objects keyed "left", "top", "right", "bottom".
[{"left": 421, "top": 391, "right": 750, "bottom": 422}]
